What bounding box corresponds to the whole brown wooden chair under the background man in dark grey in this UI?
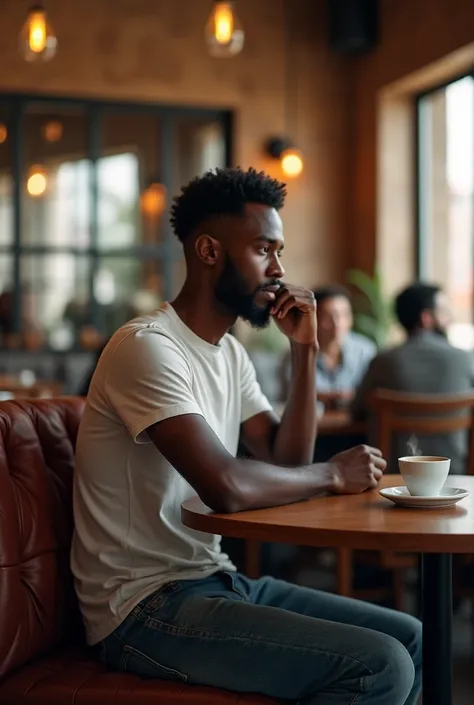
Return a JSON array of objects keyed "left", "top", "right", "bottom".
[{"left": 337, "top": 389, "right": 474, "bottom": 609}]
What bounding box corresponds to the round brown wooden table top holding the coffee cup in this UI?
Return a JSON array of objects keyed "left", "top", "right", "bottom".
[{"left": 181, "top": 475, "right": 474, "bottom": 553}]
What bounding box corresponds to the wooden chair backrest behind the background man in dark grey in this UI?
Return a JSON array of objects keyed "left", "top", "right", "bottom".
[{"left": 371, "top": 389, "right": 474, "bottom": 475}]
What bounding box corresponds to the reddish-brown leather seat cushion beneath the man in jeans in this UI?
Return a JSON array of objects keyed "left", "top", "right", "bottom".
[{"left": 0, "top": 650, "right": 277, "bottom": 705}]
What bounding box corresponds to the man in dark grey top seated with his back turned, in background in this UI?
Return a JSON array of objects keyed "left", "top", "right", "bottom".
[{"left": 352, "top": 282, "right": 474, "bottom": 473}]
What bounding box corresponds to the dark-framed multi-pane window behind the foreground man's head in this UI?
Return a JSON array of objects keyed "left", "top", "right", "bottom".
[{"left": 0, "top": 95, "right": 230, "bottom": 351}]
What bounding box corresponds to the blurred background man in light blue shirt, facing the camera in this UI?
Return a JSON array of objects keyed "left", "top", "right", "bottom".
[{"left": 284, "top": 285, "right": 377, "bottom": 408}]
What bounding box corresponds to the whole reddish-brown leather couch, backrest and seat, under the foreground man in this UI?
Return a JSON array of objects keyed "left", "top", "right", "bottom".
[{"left": 0, "top": 397, "right": 275, "bottom": 705}]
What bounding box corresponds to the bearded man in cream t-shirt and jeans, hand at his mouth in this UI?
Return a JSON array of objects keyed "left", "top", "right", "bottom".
[{"left": 72, "top": 169, "right": 421, "bottom": 705}]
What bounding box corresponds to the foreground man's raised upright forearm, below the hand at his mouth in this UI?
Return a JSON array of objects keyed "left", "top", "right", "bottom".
[{"left": 273, "top": 343, "right": 318, "bottom": 465}]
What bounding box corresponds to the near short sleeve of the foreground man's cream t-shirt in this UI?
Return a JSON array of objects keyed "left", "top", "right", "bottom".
[{"left": 105, "top": 328, "right": 203, "bottom": 443}]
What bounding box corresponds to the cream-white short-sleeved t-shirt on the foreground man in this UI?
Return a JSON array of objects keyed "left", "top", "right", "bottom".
[{"left": 71, "top": 304, "right": 271, "bottom": 644}]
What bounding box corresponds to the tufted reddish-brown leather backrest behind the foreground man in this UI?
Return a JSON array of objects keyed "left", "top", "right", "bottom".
[{"left": 0, "top": 397, "right": 84, "bottom": 677}]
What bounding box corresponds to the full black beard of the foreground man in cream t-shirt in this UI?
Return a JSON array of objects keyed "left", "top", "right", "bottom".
[{"left": 214, "top": 254, "right": 280, "bottom": 328}]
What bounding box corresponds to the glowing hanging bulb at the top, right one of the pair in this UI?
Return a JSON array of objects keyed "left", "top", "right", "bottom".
[{"left": 206, "top": 0, "right": 245, "bottom": 58}]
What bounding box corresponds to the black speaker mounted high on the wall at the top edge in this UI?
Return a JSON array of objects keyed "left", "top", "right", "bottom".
[{"left": 326, "top": 0, "right": 379, "bottom": 54}]
